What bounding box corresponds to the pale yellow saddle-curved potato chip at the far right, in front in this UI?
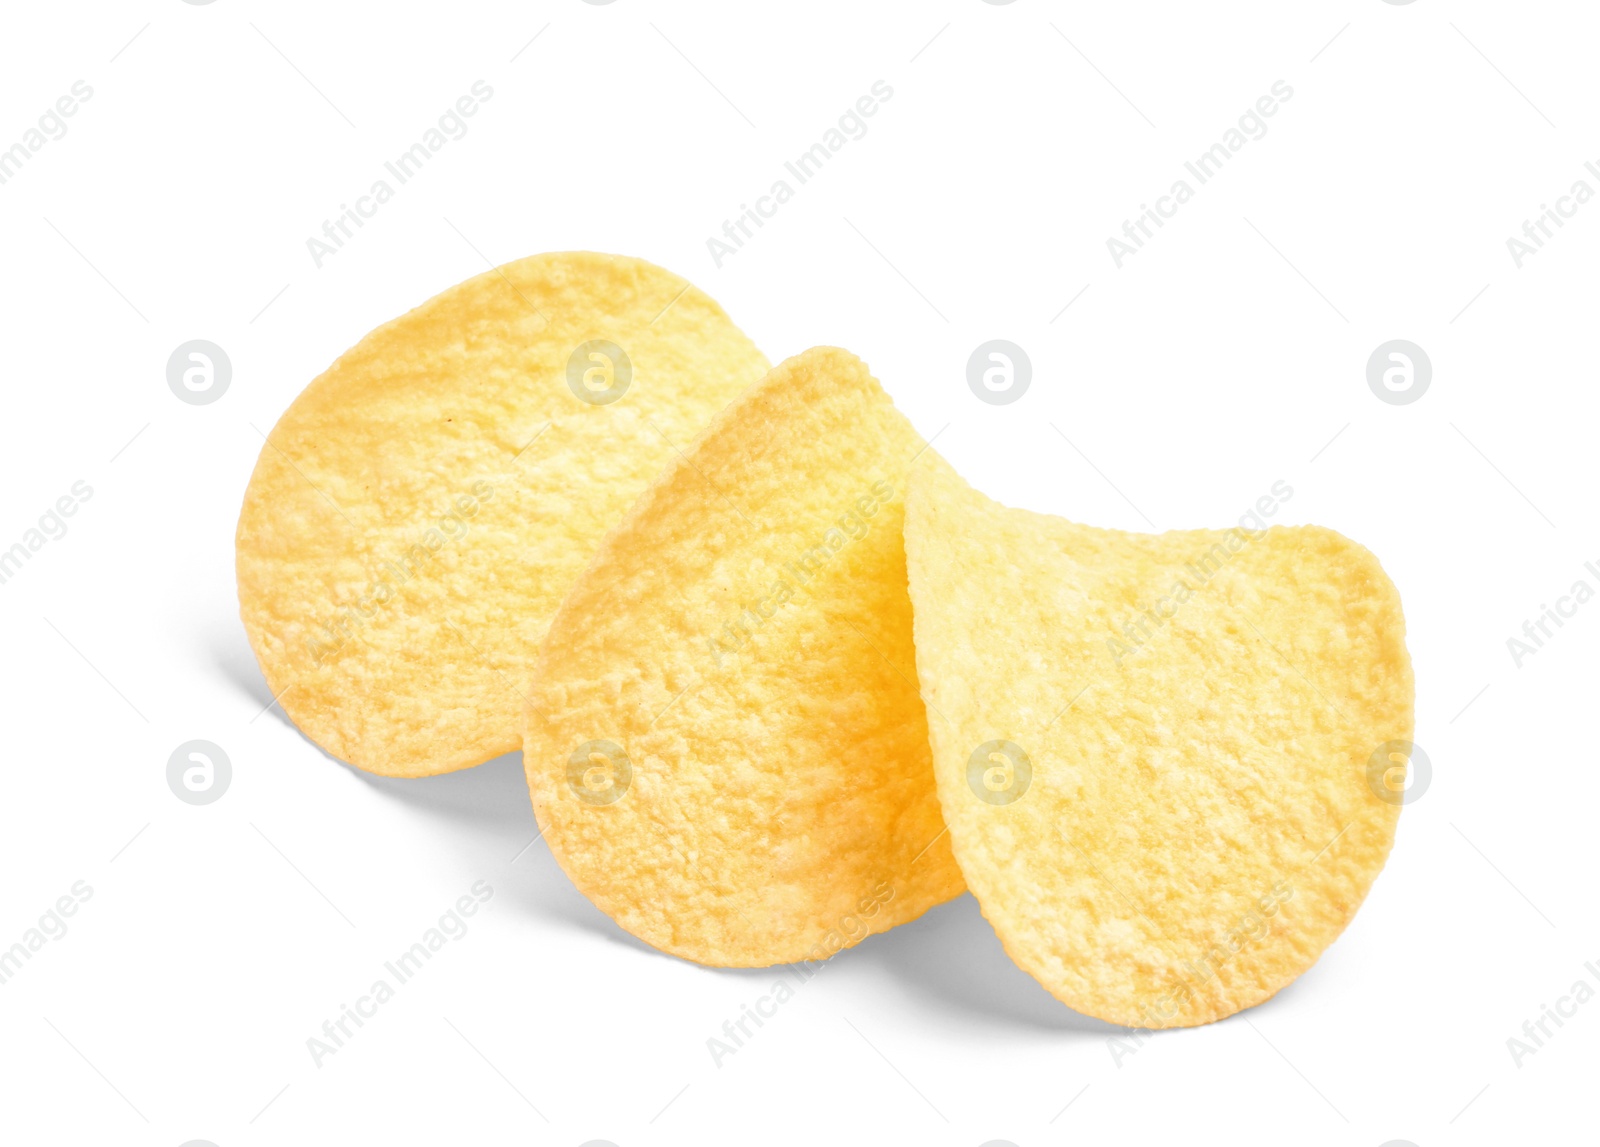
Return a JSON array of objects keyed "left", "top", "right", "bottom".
[{"left": 906, "top": 453, "right": 1413, "bottom": 1027}]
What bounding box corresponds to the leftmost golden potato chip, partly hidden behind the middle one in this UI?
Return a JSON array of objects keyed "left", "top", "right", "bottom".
[{"left": 237, "top": 253, "right": 768, "bottom": 776}]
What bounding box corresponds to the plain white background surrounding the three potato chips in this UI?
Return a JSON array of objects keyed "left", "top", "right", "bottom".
[{"left": 0, "top": 0, "right": 1600, "bottom": 1147}]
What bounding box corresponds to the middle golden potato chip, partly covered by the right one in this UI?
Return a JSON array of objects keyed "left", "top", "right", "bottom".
[{"left": 523, "top": 347, "right": 962, "bottom": 966}]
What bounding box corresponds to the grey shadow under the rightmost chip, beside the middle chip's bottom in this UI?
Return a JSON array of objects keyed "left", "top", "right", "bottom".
[{"left": 834, "top": 893, "right": 1123, "bottom": 1035}]
